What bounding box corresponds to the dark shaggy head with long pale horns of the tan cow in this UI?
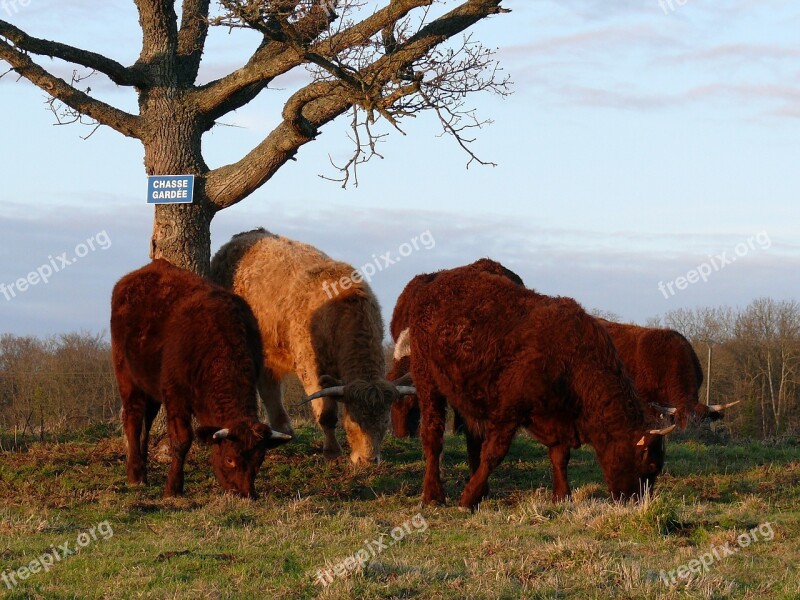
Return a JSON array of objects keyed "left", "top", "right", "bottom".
[{"left": 305, "top": 375, "right": 417, "bottom": 464}]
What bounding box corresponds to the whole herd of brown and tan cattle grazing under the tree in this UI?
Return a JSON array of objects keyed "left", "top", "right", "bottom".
[{"left": 111, "top": 229, "right": 732, "bottom": 509}]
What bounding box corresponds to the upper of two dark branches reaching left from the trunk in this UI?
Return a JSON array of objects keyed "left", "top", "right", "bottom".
[{"left": 0, "top": 20, "right": 142, "bottom": 86}]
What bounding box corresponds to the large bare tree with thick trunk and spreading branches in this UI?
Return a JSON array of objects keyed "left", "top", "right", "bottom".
[{"left": 0, "top": 0, "right": 509, "bottom": 273}]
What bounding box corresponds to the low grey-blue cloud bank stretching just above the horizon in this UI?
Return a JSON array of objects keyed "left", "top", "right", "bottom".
[{"left": 0, "top": 201, "right": 800, "bottom": 335}]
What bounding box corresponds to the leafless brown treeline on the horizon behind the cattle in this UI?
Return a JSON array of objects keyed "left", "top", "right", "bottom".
[{"left": 0, "top": 298, "right": 800, "bottom": 446}]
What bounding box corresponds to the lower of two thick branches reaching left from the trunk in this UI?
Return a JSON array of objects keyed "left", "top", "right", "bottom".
[{"left": 0, "top": 40, "right": 139, "bottom": 138}]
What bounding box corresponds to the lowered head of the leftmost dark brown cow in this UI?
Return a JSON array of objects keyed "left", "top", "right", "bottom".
[{"left": 196, "top": 421, "right": 292, "bottom": 498}]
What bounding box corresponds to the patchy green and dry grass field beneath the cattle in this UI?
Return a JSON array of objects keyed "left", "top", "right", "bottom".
[{"left": 0, "top": 426, "right": 800, "bottom": 599}]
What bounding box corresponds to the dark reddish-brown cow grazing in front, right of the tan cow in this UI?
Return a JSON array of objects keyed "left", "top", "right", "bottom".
[{"left": 401, "top": 266, "right": 674, "bottom": 508}]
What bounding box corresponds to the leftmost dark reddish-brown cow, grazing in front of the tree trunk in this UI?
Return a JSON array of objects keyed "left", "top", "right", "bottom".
[{"left": 111, "top": 260, "right": 291, "bottom": 497}]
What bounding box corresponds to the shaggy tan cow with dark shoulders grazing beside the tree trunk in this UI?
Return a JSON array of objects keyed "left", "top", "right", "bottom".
[{"left": 211, "top": 229, "right": 398, "bottom": 462}]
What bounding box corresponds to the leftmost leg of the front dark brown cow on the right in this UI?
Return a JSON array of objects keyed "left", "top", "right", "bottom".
[{"left": 417, "top": 387, "right": 447, "bottom": 504}]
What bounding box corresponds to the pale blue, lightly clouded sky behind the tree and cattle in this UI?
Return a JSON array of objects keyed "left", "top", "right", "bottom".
[{"left": 0, "top": 0, "right": 800, "bottom": 336}]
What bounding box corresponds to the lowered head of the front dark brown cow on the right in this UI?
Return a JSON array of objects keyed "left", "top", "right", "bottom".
[{"left": 595, "top": 425, "right": 676, "bottom": 500}]
